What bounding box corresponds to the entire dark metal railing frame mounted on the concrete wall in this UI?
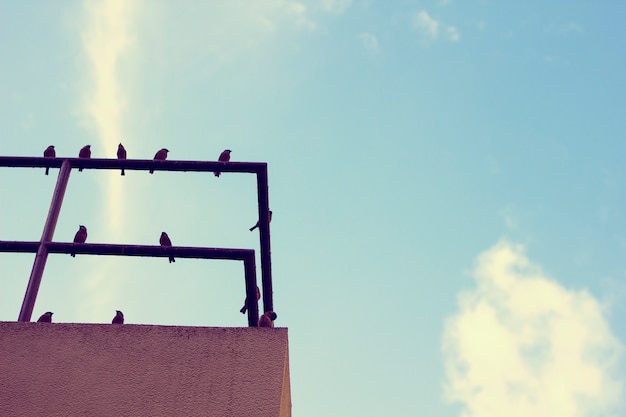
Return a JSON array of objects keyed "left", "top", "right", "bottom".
[{"left": 0, "top": 156, "right": 274, "bottom": 326}]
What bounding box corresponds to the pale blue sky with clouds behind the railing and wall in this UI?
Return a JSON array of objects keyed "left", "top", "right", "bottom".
[{"left": 0, "top": 0, "right": 626, "bottom": 417}]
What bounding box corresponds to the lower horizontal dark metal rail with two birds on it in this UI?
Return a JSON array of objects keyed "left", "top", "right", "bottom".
[{"left": 0, "top": 240, "right": 254, "bottom": 261}]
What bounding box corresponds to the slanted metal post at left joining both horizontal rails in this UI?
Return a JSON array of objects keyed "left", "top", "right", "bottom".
[{"left": 18, "top": 160, "right": 72, "bottom": 321}]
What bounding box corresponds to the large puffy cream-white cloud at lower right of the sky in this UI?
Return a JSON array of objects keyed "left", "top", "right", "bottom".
[{"left": 443, "top": 242, "right": 623, "bottom": 417}]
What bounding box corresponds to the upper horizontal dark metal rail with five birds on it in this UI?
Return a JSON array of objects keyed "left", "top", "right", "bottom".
[{"left": 0, "top": 156, "right": 267, "bottom": 174}]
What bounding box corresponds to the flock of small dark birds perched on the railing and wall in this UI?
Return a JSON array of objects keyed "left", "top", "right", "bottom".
[{"left": 37, "top": 143, "right": 277, "bottom": 327}]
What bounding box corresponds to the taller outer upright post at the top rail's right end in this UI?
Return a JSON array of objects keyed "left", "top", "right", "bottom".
[{"left": 256, "top": 164, "right": 274, "bottom": 312}]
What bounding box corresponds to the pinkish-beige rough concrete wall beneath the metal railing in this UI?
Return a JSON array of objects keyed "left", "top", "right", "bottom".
[{"left": 0, "top": 322, "right": 291, "bottom": 417}]
